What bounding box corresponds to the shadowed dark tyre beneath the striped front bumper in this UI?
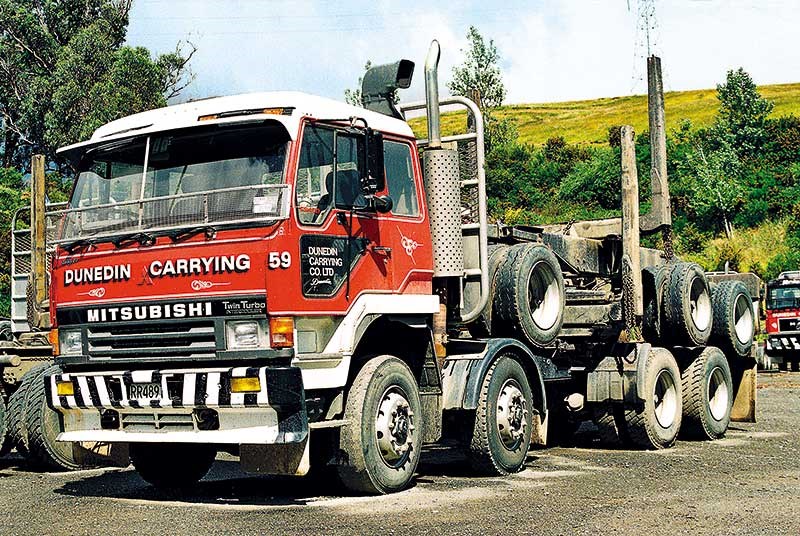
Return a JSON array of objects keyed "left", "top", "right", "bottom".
[{"left": 130, "top": 443, "right": 217, "bottom": 489}]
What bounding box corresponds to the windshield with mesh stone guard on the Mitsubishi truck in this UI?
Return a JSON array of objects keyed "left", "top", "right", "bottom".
[{"left": 51, "top": 124, "right": 289, "bottom": 242}]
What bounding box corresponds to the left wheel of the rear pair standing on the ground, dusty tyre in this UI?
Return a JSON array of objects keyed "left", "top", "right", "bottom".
[{"left": 625, "top": 348, "right": 682, "bottom": 449}]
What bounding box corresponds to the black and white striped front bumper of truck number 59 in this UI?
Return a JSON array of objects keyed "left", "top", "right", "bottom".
[{"left": 45, "top": 367, "right": 308, "bottom": 445}]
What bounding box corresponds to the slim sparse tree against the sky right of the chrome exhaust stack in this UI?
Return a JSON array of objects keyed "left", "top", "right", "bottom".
[{"left": 447, "top": 26, "right": 506, "bottom": 112}]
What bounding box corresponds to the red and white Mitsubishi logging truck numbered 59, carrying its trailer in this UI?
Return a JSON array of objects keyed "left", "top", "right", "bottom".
[{"left": 39, "top": 42, "right": 755, "bottom": 493}]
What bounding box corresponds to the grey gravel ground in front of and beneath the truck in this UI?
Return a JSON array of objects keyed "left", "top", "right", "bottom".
[{"left": 0, "top": 373, "right": 800, "bottom": 535}]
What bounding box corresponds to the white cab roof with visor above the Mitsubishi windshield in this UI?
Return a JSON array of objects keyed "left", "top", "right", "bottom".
[{"left": 58, "top": 91, "right": 414, "bottom": 156}]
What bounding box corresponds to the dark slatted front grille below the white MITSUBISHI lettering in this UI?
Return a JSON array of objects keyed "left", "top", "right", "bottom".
[{"left": 86, "top": 320, "right": 217, "bottom": 359}]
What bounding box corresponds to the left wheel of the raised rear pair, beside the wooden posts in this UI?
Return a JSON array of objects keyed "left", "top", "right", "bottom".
[{"left": 662, "top": 262, "right": 713, "bottom": 346}]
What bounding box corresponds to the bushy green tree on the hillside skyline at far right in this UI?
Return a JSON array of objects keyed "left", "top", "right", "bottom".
[{"left": 714, "top": 67, "right": 773, "bottom": 157}]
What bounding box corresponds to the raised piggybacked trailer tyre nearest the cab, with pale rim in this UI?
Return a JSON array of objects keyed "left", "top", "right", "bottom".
[{"left": 494, "top": 244, "right": 565, "bottom": 346}]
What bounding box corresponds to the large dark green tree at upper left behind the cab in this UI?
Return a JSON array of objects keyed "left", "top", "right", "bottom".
[{"left": 0, "top": 0, "right": 194, "bottom": 168}]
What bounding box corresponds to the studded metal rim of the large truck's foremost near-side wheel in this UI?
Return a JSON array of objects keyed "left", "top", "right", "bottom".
[{"left": 375, "top": 386, "right": 416, "bottom": 468}]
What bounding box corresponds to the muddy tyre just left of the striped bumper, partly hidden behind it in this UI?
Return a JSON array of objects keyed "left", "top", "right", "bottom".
[{"left": 25, "top": 366, "right": 84, "bottom": 471}]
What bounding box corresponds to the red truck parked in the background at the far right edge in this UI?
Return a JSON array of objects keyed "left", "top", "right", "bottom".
[{"left": 766, "top": 271, "right": 800, "bottom": 371}]
